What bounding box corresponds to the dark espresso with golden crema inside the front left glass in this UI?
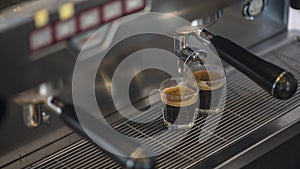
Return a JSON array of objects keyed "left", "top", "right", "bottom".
[{"left": 161, "top": 86, "right": 198, "bottom": 125}]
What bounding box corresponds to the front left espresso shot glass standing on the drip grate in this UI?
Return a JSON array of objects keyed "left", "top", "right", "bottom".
[{"left": 159, "top": 78, "right": 199, "bottom": 130}]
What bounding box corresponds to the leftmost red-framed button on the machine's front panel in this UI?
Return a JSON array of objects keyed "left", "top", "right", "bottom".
[{"left": 29, "top": 26, "right": 53, "bottom": 51}]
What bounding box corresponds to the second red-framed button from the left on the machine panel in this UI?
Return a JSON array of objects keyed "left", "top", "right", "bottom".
[{"left": 55, "top": 18, "right": 77, "bottom": 41}]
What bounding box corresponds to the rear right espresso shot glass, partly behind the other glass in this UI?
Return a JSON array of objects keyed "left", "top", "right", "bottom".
[{"left": 190, "top": 64, "right": 226, "bottom": 115}]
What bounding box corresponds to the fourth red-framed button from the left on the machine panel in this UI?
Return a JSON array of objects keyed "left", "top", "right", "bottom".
[{"left": 102, "top": 0, "right": 123, "bottom": 22}]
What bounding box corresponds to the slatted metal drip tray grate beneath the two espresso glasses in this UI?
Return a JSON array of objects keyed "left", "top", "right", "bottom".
[{"left": 28, "top": 41, "right": 300, "bottom": 168}]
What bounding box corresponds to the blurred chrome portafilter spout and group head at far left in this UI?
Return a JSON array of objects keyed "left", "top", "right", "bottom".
[{"left": 13, "top": 79, "right": 63, "bottom": 128}]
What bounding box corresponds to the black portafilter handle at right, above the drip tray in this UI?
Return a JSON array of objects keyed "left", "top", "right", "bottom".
[{"left": 203, "top": 30, "right": 298, "bottom": 99}]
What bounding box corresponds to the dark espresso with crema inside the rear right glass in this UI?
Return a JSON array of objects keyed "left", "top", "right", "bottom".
[{"left": 194, "top": 70, "right": 224, "bottom": 110}]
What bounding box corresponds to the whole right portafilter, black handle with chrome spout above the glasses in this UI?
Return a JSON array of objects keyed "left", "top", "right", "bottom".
[{"left": 174, "top": 6, "right": 298, "bottom": 99}]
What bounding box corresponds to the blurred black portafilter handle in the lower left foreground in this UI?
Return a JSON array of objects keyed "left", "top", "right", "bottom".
[{"left": 47, "top": 98, "right": 156, "bottom": 169}]
